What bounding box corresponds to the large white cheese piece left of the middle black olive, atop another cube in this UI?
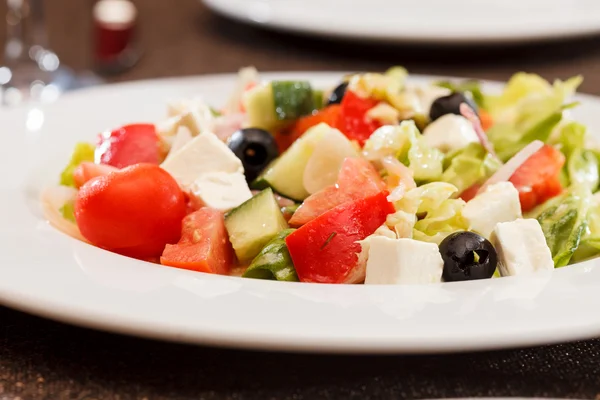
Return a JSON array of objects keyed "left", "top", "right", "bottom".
[{"left": 161, "top": 132, "right": 244, "bottom": 190}]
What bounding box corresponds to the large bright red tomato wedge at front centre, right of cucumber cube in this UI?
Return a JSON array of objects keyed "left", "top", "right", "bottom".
[{"left": 285, "top": 191, "right": 394, "bottom": 283}]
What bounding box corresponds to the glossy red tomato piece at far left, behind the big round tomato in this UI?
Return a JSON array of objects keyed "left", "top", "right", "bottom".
[{"left": 96, "top": 124, "right": 161, "bottom": 168}]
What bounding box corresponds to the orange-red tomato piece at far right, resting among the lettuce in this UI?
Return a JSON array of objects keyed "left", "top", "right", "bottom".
[{"left": 509, "top": 144, "right": 565, "bottom": 212}]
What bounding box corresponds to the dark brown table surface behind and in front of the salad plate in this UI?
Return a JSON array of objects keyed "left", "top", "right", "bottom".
[{"left": 0, "top": 0, "right": 600, "bottom": 400}]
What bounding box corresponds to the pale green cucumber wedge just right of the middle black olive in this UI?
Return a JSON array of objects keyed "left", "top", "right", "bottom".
[{"left": 253, "top": 123, "right": 332, "bottom": 201}]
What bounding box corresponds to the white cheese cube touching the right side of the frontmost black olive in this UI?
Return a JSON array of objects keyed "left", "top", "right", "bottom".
[{"left": 491, "top": 219, "right": 554, "bottom": 276}]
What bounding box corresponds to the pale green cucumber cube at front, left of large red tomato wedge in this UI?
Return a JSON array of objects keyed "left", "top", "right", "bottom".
[{"left": 225, "top": 188, "right": 288, "bottom": 262}]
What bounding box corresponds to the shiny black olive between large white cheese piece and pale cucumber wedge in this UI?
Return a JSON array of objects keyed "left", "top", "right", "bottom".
[{"left": 227, "top": 128, "right": 279, "bottom": 182}]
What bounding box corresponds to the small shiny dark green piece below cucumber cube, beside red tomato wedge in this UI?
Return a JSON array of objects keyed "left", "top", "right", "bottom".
[{"left": 242, "top": 229, "right": 298, "bottom": 282}]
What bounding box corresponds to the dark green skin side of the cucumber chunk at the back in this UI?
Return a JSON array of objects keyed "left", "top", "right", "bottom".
[{"left": 271, "top": 81, "right": 315, "bottom": 121}]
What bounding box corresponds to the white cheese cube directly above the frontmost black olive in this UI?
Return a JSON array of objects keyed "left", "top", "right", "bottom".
[{"left": 462, "top": 182, "right": 521, "bottom": 238}]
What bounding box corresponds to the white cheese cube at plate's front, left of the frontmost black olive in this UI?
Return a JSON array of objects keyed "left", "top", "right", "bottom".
[{"left": 365, "top": 236, "right": 444, "bottom": 284}]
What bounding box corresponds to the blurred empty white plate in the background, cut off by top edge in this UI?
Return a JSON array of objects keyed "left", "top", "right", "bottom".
[{"left": 204, "top": 0, "right": 600, "bottom": 43}]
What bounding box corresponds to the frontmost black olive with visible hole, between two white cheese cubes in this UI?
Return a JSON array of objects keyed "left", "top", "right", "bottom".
[{"left": 440, "top": 231, "right": 498, "bottom": 282}]
